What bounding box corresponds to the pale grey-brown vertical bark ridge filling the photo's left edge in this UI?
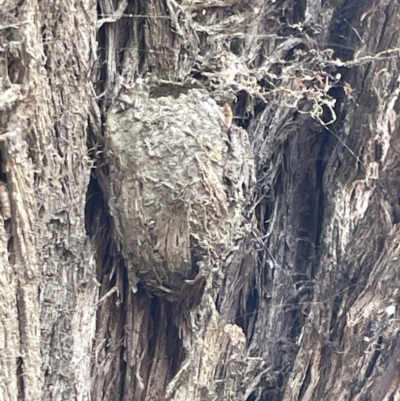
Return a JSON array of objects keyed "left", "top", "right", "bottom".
[{"left": 0, "top": 1, "right": 98, "bottom": 400}]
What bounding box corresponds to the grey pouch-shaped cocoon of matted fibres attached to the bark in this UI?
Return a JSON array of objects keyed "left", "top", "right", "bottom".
[{"left": 106, "top": 89, "right": 253, "bottom": 298}]
